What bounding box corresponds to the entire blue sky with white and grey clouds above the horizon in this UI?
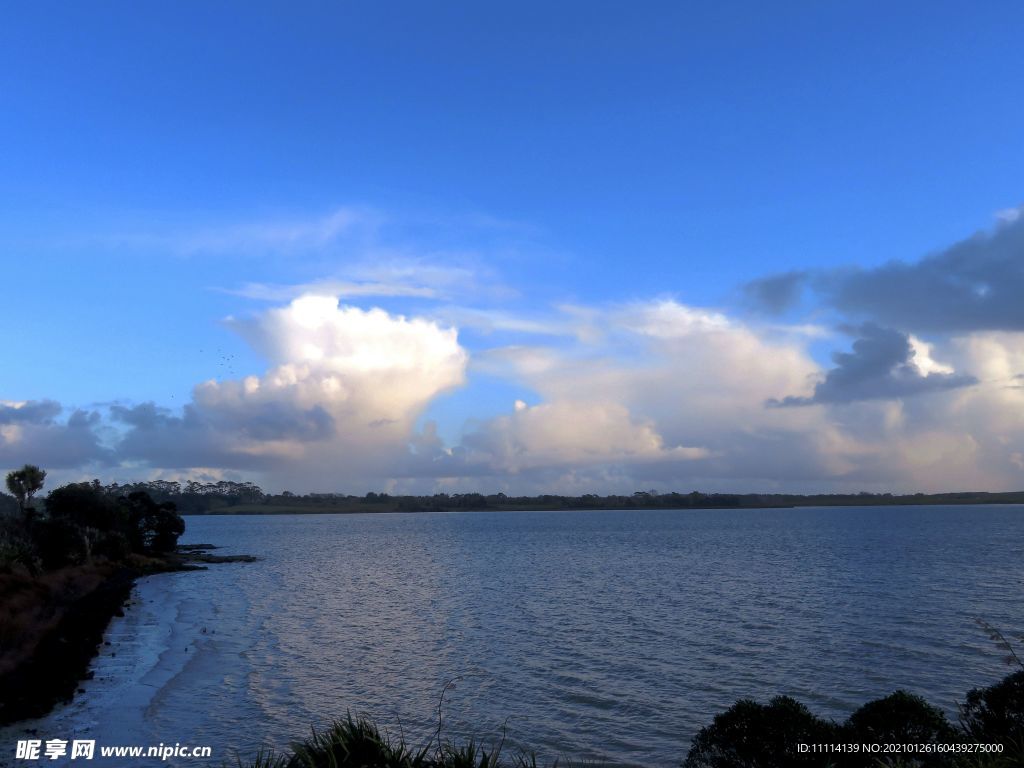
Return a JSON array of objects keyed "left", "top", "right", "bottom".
[{"left": 0, "top": 2, "right": 1024, "bottom": 493}]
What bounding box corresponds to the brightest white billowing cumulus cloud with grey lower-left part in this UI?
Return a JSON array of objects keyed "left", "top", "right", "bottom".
[{"left": 115, "top": 295, "right": 467, "bottom": 488}]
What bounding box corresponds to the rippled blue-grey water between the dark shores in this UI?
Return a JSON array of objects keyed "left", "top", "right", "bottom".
[{"left": 8, "top": 507, "right": 1024, "bottom": 766}]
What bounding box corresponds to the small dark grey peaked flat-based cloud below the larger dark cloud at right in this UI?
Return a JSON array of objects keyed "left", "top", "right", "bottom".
[{"left": 768, "top": 323, "right": 978, "bottom": 407}]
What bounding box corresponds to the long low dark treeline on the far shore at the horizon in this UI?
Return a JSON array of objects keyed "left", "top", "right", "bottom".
[{"left": 9, "top": 480, "right": 1024, "bottom": 515}]
